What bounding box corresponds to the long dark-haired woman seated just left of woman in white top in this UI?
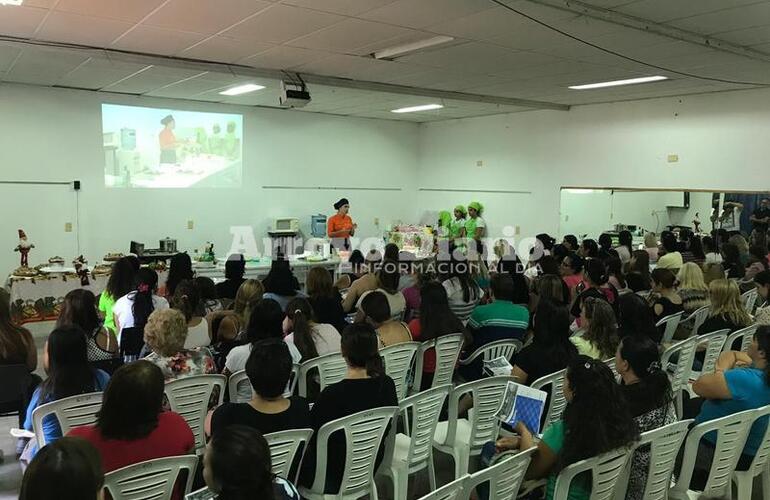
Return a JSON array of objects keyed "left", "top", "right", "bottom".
[{"left": 56, "top": 288, "right": 118, "bottom": 361}]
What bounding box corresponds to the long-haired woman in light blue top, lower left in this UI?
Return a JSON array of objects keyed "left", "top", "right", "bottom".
[{"left": 21, "top": 325, "right": 110, "bottom": 463}]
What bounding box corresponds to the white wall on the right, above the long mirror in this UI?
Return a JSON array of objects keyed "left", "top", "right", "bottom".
[{"left": 418, "top": 86, "right": 770, "bottom": 246}]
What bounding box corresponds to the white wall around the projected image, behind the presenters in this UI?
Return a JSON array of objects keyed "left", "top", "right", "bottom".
[{"left": 0, "top": 84, "right": 419, "bottom": 273}]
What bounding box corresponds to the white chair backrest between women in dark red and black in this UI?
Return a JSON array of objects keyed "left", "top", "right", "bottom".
[{"left": 164, "top": 375, "right": 222, "bottom": 449}]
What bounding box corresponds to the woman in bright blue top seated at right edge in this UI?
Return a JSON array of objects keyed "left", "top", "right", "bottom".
[{"left": 685, "top": 325, "right": 770, "bottom": 489}]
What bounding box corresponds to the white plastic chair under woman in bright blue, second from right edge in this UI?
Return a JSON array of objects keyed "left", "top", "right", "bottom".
[{"left": 669, "top": 410, "right": 756, "bottom": 500}]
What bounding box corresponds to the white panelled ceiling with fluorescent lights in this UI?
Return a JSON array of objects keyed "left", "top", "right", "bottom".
[{"left": 0, "top": 0, "right": 770, "bottom": 122}]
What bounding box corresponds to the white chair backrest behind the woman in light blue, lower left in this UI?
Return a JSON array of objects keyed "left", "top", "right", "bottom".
[{"left": 32, "top": 392, "right": 102, "bottom": 448}]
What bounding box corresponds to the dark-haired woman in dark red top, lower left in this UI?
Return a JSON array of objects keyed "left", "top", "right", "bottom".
[{"left": 68, "top": 360, "right": 195, "bottom": 473}]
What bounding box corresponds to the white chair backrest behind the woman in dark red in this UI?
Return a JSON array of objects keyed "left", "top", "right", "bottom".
[{"left": 104, "top": 455, "right": 198, "bottom": 500}]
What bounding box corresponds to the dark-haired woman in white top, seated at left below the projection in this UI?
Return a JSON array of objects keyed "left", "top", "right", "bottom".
[{"left": 112, "top": 267, "right": 169, "bottom": 342}]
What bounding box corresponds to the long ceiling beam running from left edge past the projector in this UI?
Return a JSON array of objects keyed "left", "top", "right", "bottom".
[{"left": 0, "top": 35, "right": 570, "bottom": 111}]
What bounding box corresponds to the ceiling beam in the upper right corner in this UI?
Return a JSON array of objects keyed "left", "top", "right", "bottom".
[{"left": 516, "top": 0, "right": 770, "bottom": 62}]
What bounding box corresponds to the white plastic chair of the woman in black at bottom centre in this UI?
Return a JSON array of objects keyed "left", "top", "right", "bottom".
[{"left": 299, "top": 406, "right": 398, "bottom": 500}]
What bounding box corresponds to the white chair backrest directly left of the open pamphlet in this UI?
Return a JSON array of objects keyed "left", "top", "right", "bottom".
[{"left": 445, "top": 376, "right": 516, "bottom": 454}]
